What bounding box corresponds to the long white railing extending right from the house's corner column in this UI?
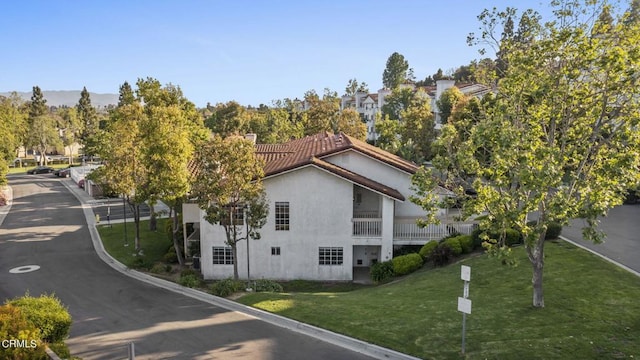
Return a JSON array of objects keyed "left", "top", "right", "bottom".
[{"left": 393, "top": 219, "right": 477, "bottom": 241}]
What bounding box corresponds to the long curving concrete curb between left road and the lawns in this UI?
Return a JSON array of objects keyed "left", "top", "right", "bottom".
[{"left": 63, "top": 182, "right": 419, "bottom": 360}]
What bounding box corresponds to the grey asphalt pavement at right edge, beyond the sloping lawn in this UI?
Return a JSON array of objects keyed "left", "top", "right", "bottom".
[{"left": 562, "top": 205, "right": 640, "bottom": 273}]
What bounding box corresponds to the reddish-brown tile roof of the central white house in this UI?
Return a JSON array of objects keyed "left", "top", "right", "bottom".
[{"left": 256, "top": 132, "right": 418, "bottom": 201}]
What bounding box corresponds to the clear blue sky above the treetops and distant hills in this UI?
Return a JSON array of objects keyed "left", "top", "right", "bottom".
[{"left": 0, "top": 0, "right": 548, "bottom": 107}]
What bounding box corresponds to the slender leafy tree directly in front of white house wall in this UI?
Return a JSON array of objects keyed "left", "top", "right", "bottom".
[{"left": 192, "top": 135, "right": 269, "bottom": 280}]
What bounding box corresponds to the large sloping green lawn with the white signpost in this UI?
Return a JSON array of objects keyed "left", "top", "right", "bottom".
[{"left": 237, "top": 241, "right": 640, "bottom": 360}]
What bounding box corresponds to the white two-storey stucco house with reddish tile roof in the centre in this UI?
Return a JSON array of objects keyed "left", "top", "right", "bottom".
[{"left": 183, "top": 132, "right": 473, "bottom": 281}]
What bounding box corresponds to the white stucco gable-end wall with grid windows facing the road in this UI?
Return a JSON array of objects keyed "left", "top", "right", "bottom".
[{"left": 201, "top": 166, "right": 353, "bottom": 280}]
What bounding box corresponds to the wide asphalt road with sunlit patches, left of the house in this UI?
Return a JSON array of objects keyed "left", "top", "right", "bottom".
[{"left": 0, "top": 175, "right": 376, "bottom": 360}]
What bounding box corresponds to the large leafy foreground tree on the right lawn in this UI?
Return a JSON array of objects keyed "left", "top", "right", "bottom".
[{"left": 412, "top": 1, "right": 640, "bottom": 307}]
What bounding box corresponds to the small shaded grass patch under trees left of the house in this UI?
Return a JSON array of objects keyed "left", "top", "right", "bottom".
[{"left": 98, "top": 219, "right": 172, "bottom": 267}]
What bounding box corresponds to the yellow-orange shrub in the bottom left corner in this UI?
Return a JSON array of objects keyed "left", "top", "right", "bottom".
[{"left": 0, "top": 304, "right": 48, "bottom": 359}]
